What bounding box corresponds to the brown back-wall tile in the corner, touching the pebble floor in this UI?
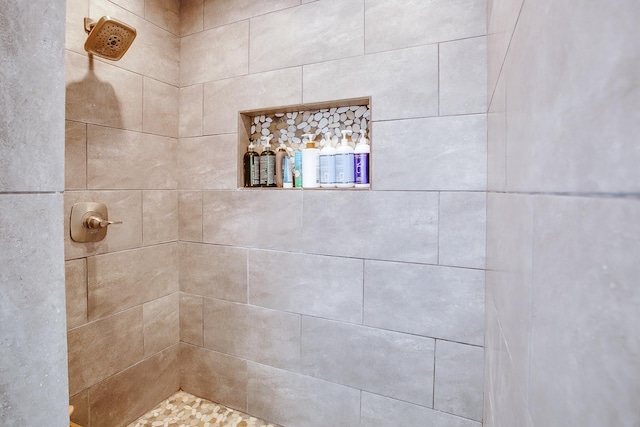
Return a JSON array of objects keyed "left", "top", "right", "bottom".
[{"left": 180, "top": 344, "right": 247, "bottom": 411}]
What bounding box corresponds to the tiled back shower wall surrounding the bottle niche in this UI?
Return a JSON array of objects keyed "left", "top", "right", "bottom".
[{"left": 177, "top": 0, "right": 486, "bottom": 427}]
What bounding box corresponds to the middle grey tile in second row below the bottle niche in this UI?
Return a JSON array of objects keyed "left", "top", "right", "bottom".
[{"left": 249, "top": 251, "right": 363, "bottom": 323}]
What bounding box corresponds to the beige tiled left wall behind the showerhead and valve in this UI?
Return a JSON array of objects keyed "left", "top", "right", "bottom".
[{"left": 64, "top": 0, "right": 180, "bottom": 427}]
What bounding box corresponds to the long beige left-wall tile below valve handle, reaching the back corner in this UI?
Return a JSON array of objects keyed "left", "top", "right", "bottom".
[{"left": 87, "top": 244, "right": 178, "bottom": 319}]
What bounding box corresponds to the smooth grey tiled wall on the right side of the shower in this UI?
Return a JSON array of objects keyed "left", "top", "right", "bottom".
[{"left": 484, "top": 0, "right": 640, "bottom": 427}]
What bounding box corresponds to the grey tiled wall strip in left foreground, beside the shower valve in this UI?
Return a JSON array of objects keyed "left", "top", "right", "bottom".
[{"left": 0, "top": 0, "right": 68, "bottom": 426}]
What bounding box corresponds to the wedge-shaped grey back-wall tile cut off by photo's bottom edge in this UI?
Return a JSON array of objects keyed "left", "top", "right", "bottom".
[{"left": 360, "top": 392, "right": 482, "bottom": 427}]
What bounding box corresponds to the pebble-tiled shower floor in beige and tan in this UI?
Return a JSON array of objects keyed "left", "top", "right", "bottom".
[{"left": 127, "top": 391, "right": 280, "bottom": 427}]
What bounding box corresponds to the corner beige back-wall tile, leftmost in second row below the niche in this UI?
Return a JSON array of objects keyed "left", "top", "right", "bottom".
[{"left": 180, "top": 243, "right": 247, "bottom": 303}]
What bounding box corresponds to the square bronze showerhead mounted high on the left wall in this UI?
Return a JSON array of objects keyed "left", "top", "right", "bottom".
[{"left": 84, "top": 16, "right": 137, "bottom": 61}]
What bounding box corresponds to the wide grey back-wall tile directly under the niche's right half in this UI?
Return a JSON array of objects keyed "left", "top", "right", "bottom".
[{"left": 300, "top": 190, "right": 438, "bottom": 264}]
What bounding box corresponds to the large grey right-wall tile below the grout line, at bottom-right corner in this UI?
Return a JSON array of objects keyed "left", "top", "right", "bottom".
[{"left": 529, "top": 196, "right": 640, "bottom": 426}]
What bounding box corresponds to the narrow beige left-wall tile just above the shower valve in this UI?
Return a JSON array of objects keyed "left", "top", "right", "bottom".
[{"left": 64, "top": 120, "right": 87, "bottom": 190}]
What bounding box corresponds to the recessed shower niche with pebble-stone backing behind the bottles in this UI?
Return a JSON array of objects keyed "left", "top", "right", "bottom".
[{"left": 237, "top": 97, "right": 373, "bottom": 190}]
